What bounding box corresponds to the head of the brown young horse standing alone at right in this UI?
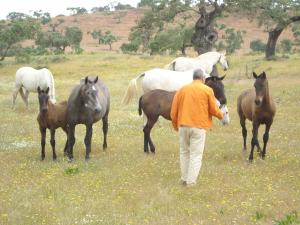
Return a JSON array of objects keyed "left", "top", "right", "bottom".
[{"left": 253, "top": 72, "right": 268, "bottom": 107}]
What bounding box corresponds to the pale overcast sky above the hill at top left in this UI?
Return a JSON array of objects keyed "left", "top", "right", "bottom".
[{"left": 0, "top": 0, "right": 140, "bottom": 19}]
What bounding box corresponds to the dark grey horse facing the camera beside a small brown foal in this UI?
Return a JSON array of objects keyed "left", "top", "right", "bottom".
[{"left": 67, "top": 76, "right": 110, "bottom": 161}]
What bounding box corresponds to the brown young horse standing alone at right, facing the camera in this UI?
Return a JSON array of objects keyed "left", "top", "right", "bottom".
[{"left": 237, "top": 72, "right": 276, "bottom": 162}]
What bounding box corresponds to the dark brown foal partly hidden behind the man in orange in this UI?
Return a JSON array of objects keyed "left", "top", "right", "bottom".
[{"left": 138, "top": 76, "right": 229, "bottom": 153}]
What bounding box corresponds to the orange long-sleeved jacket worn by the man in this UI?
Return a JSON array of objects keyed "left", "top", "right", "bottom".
[{"left": 171, "top": 80, "right": 223, "bottom": 130}]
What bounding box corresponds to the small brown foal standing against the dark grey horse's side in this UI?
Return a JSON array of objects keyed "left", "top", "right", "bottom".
[{"left": 37, "top": 86, "right": 68, "bottom": 160}]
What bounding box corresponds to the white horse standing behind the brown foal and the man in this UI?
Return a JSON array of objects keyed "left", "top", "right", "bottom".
[{"left": 122, "top": 68, "right": 229, "bottom": 124}]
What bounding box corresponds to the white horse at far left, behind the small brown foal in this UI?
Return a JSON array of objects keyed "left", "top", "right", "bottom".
[{"left": 12, "top": 67, "right": 56, "bottom": 108}]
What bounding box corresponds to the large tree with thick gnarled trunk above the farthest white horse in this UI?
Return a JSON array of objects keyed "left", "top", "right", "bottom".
[{"left": 129, "top": 0, "right": 225, "bottom": 54}]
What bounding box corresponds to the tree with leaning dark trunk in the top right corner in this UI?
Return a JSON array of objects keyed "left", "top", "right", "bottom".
[{"left": 227, "top": 0, "right": 300, "bottom": 59}]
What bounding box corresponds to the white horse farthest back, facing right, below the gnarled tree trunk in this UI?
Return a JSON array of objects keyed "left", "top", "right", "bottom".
[{"left": 165, "top": 52, "right": 228, "bottom": 74}]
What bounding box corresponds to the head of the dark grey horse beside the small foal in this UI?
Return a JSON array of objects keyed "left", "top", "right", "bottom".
[{"left": 80, "top": 77, "right": 102, "bottom": 113}]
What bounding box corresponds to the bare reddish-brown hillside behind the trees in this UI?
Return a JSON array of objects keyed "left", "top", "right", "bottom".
[{"left": 45, "top": 9, "right": 293, "bottom": 53}]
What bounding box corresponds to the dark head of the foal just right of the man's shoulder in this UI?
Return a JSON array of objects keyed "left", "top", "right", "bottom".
[{"left": 205, "top": 75, "right": 227, "bottom": 105}]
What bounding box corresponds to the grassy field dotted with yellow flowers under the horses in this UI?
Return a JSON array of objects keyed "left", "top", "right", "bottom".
[{"left": 0, "top": 53, "right": 300, "bottom": 225}]
